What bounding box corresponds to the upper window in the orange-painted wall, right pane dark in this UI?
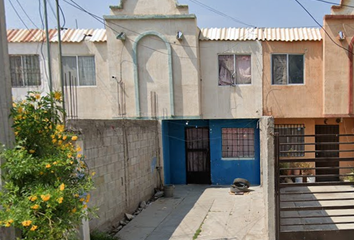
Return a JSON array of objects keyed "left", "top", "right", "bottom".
[{"left": 272, "top": 54, "right": 304, "bottom": 85}]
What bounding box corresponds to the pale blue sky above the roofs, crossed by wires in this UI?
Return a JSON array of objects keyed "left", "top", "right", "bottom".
[{"left": 4, "top": 0, "right": 340, "bottom": 29}]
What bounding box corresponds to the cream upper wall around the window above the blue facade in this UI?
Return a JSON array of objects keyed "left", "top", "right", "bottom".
[{"left": 200, "top": 41, "right": 263, "bottom": 119}]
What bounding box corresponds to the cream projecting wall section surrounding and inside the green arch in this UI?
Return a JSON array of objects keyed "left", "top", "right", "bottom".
[{"left": 107, "top": 19, "right": 200, "bottom": 118}]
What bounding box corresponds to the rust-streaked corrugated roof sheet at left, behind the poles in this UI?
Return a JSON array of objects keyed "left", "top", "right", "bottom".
[{"left": 7, "top": 29, "right": 107, "bottom": 43}]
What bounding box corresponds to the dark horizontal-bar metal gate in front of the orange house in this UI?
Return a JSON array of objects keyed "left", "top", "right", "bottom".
[{"left": 275, "top": 132, "right": 354, "bottom": 240}]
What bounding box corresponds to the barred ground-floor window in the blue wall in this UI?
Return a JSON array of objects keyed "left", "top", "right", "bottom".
[{"left": 222, "top": 128, "right": 255, "bottom": 158}]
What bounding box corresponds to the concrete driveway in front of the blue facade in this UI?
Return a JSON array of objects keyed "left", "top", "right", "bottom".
[{"left": 117, "top": 185, "right": 267, "bottom": 240}]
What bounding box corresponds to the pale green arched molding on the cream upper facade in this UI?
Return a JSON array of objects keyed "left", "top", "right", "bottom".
[{"left": 133, "top": 31, "right": 175, "bottom": 117}]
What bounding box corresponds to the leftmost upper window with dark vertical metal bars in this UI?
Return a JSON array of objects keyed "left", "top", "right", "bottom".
[{"left": 10, "top": 55, "right": 41, "bottom": 87}]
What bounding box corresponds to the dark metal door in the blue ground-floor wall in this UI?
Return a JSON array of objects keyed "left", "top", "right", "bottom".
[{"left": 186, "top": 127, "right": 211, "bottom": 184}]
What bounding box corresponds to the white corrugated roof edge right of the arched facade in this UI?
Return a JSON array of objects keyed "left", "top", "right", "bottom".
[{"left": 200, "top": 28, "right": 322, "bottom": 42}]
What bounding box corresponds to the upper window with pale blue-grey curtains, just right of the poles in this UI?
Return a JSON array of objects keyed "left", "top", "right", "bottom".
[{"left": 63, "top": 56, "right": 96, "bottom": 86}]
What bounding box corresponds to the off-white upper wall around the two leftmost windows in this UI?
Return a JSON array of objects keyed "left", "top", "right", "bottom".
[{"left": 9, "top": 41, "right": 112, "bottom": 119}]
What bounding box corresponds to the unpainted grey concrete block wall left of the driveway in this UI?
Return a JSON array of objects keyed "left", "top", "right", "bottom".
[{"left": 68, "top": 120, "right": 160, "bottom": 230}]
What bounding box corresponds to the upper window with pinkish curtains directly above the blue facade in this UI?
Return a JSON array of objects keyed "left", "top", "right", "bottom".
[{"left": 219, "top": 55, "right": 251, "bottom": 86}]
